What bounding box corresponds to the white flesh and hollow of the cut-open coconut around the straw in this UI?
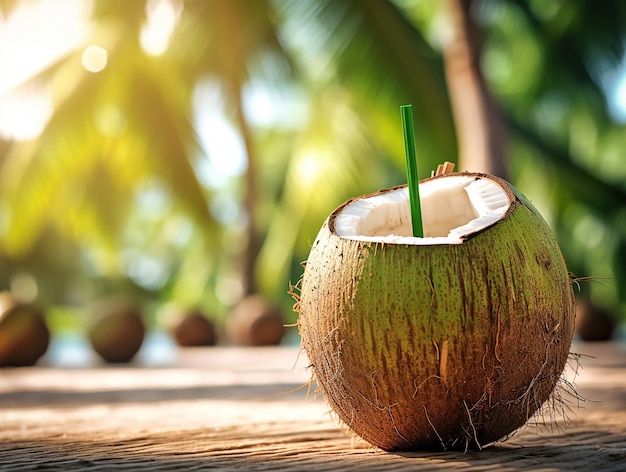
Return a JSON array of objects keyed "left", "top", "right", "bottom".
[{"left": 335, "top": 174, "right": 511, "bottom": 245}]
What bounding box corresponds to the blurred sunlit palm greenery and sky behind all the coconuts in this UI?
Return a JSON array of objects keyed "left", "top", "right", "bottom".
[{"left": 0, "top": 0, "right": 626, "bottom": 364}]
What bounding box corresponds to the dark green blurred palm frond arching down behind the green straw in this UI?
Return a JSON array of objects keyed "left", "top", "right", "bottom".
[{"left": 281, "top": 0, "right": 456, "bottom": 172}]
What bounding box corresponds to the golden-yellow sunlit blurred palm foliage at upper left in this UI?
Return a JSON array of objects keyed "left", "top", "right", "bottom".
[{"left": 2, "top": 1, "right": 218, "bottom": 302}]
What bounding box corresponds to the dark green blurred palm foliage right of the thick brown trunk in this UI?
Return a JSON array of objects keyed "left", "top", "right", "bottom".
[{"left": 475, "top": 0, "right": 626, "bottom": 316}]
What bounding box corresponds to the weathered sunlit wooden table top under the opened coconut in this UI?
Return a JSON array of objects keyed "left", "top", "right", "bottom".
[{"left": 0, "top": 342, "right": 626, "bottom": 472}]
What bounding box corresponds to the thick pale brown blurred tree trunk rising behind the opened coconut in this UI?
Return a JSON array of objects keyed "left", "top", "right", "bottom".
[{"left": 444, "top": 0, "right": 507, "bottom": 178}]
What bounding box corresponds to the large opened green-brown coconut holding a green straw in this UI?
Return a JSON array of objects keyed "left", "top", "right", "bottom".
[{"left": 295, "top": 173, "right": 575, "bottom": 451}]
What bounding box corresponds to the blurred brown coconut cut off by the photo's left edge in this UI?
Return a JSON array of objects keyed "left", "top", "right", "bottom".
[{"left": 0, "top": 292, "right": 50, "bottom": 367}]
